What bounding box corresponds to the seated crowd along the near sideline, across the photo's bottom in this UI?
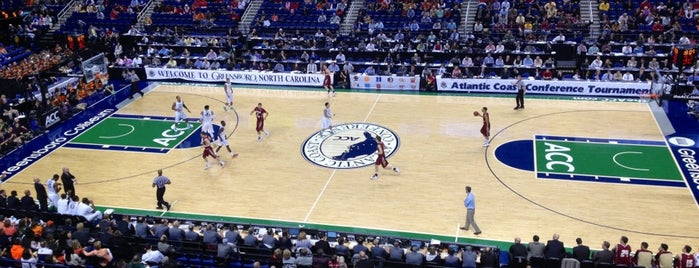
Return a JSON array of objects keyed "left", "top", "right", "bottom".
[{"left": 0, "top": 184, "right": 699, "bottom": 268}]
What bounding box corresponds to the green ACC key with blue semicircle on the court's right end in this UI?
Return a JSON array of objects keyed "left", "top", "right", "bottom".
[{"left": 495, "top": 135, "right": 688, "bottom": 187}]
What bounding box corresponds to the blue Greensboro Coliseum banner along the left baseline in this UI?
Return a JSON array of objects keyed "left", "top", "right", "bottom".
[{"left": 4, "top": 109, "right": 116, "bottom": 178}]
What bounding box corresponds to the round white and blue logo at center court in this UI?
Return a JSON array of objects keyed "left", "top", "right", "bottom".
[{"left": 301, "top": 123, "right": 400, "bottom": 169}]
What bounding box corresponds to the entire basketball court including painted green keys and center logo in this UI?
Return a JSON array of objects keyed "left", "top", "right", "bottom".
[{"left": 2, "top": 84, "right": 699, "bottom": 252}]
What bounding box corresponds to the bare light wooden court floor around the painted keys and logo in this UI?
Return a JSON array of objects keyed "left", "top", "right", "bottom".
[{"left": 3, "top": 84, "right": 699, "bottom": 252}]
